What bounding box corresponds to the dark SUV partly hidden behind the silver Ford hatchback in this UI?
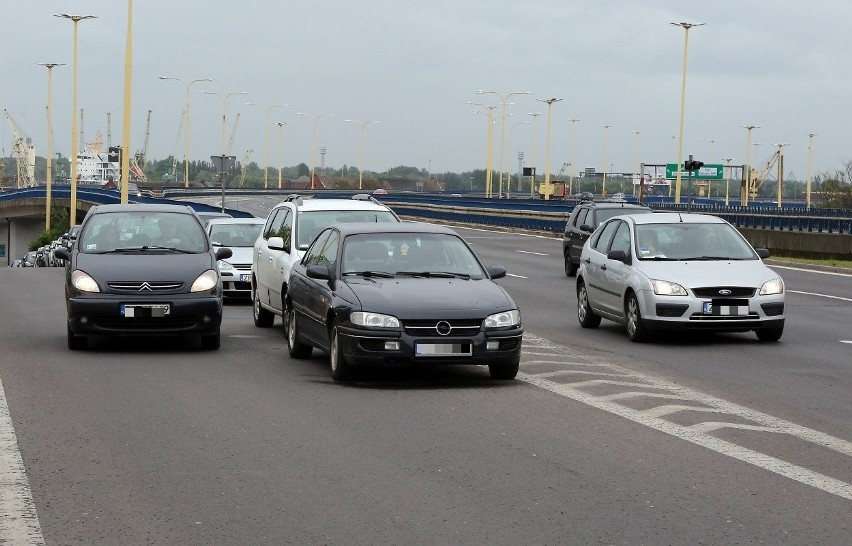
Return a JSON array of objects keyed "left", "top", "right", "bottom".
[{"left": 562, "top": 201, "right": 652, "bottom": 277}]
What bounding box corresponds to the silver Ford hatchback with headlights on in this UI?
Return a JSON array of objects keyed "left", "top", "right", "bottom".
[{"left": 577, "top": 212, "right": 784, "bottom": 341}]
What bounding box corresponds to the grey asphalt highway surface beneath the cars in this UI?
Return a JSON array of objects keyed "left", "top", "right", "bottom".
[{"left": 0, "top": 198, "right": 852, "bottom": 544}]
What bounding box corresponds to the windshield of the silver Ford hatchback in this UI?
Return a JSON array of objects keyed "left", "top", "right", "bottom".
[{"left": 636, "top": 223, "right": 757, "bottom": 260}]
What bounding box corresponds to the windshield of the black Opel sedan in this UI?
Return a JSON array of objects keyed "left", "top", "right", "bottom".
[{"left": 340, "top": 233, "right": 487, "bottom": 279}]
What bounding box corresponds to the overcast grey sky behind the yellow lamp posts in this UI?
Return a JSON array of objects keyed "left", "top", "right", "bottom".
[{"left": 0, "top": 0, "right": 852, "bottom": 179}]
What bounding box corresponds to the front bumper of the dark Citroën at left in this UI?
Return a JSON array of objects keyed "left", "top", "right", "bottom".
[{"left": 67, "top": 293, "right": 222, "bottom": 336}]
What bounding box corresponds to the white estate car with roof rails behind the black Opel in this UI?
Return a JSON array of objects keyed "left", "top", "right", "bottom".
[{"left": 251, "top": 194, "right": 400, "bottom": 328}]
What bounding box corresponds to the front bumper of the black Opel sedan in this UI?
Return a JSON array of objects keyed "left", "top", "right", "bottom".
[{"left": 338, "top": 327, "right": 524, "bottom": 367}]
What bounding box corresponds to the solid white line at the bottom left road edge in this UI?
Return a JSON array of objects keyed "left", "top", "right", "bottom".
[{"left": 0, "top": 381, "right": 44, "bottom": 545}]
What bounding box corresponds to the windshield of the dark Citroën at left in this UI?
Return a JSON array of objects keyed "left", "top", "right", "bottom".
[{"left": 78, "top": 211, "right": 208, "bottom": 254}]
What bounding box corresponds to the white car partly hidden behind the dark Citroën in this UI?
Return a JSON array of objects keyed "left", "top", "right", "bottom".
[{"left": 204, "top": 217, "right": 266, "bottom": 298}]
